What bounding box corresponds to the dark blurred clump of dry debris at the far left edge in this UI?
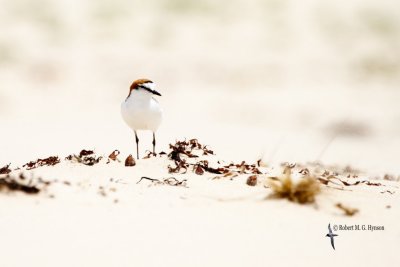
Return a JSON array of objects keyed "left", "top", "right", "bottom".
[{"left": 0, "top": 173, "right": 48, "bottom": 194}]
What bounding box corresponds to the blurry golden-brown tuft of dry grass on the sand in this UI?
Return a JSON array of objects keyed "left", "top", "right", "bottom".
[{"left": 267, "top": 166, "right": 320, "bottom": 204}]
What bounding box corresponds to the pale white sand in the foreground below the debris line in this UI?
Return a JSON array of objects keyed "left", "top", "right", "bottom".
[{"left": 0, "top": 153, "right": 400, "bottom": 266}]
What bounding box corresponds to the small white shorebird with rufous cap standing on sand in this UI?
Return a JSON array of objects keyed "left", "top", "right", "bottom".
[{"left": 121, "top": 79, "right": 163, "bottom": 159}]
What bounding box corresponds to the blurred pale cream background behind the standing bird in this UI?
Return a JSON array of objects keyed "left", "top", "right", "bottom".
[{"left": 0, "top": 0, "right": 400, "bottom": 175}]
